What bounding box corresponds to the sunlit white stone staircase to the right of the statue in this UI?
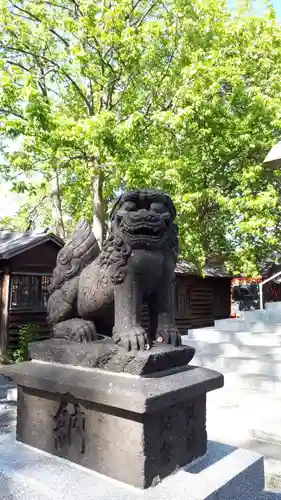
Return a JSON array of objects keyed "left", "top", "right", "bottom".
[{"left": 183, "top": 302, "right": 281, "bottom": 394}]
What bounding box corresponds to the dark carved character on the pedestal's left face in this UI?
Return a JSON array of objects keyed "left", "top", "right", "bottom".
[{"left": 53, "top": 401, "right": 85, "bottom": 454}]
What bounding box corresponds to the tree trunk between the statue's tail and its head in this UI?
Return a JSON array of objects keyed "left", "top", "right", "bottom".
[{"left": 92, "top": 170, "right": 105, "bottom": 249}]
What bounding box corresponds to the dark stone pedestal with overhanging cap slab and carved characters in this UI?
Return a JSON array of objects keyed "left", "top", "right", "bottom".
[{"left": 1, "top": 341, "right": 223, "bottom": 488}]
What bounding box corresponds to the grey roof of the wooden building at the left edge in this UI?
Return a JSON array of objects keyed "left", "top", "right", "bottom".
[{"left": 0, "top": 231, "right": 64, "bottom": 260}]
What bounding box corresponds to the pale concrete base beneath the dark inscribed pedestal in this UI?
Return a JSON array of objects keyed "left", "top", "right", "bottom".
[{"left": 0, "top": 436, "right": 270, "bottom": 500}]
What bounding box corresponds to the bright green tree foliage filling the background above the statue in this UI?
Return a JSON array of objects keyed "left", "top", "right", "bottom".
[{"left": 0, "top": 0, "right": 281, "bottom": 274}]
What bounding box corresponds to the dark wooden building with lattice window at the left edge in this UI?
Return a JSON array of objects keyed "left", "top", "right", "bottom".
[{"left": 0, "top": 231, "right": 64, "bottom": 353}]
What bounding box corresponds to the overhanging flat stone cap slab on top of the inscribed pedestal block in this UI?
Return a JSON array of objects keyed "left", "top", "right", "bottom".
[{"left": 3, "top": 361, "right": 223, "bottom": 413}]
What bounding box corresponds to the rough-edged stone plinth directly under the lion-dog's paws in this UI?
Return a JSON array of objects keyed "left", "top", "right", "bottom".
[{"left": 29, "top": 338, "right": 195, "bottom": 375}]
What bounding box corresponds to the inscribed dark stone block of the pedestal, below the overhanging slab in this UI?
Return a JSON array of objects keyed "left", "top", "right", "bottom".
[{"left": 17, "top": 388, "right": 207, "bottom": 488}]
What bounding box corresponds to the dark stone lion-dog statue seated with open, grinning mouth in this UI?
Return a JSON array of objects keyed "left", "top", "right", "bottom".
[{"left": 48, "top": 189, "right": 181, "bottom": 351}]
